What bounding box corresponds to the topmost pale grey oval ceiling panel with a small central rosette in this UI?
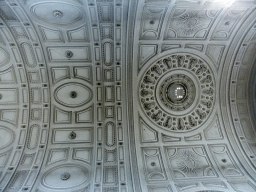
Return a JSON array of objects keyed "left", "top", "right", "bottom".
[{"left": 30, "top": 2, "right": 83, "bottom": 25}]
